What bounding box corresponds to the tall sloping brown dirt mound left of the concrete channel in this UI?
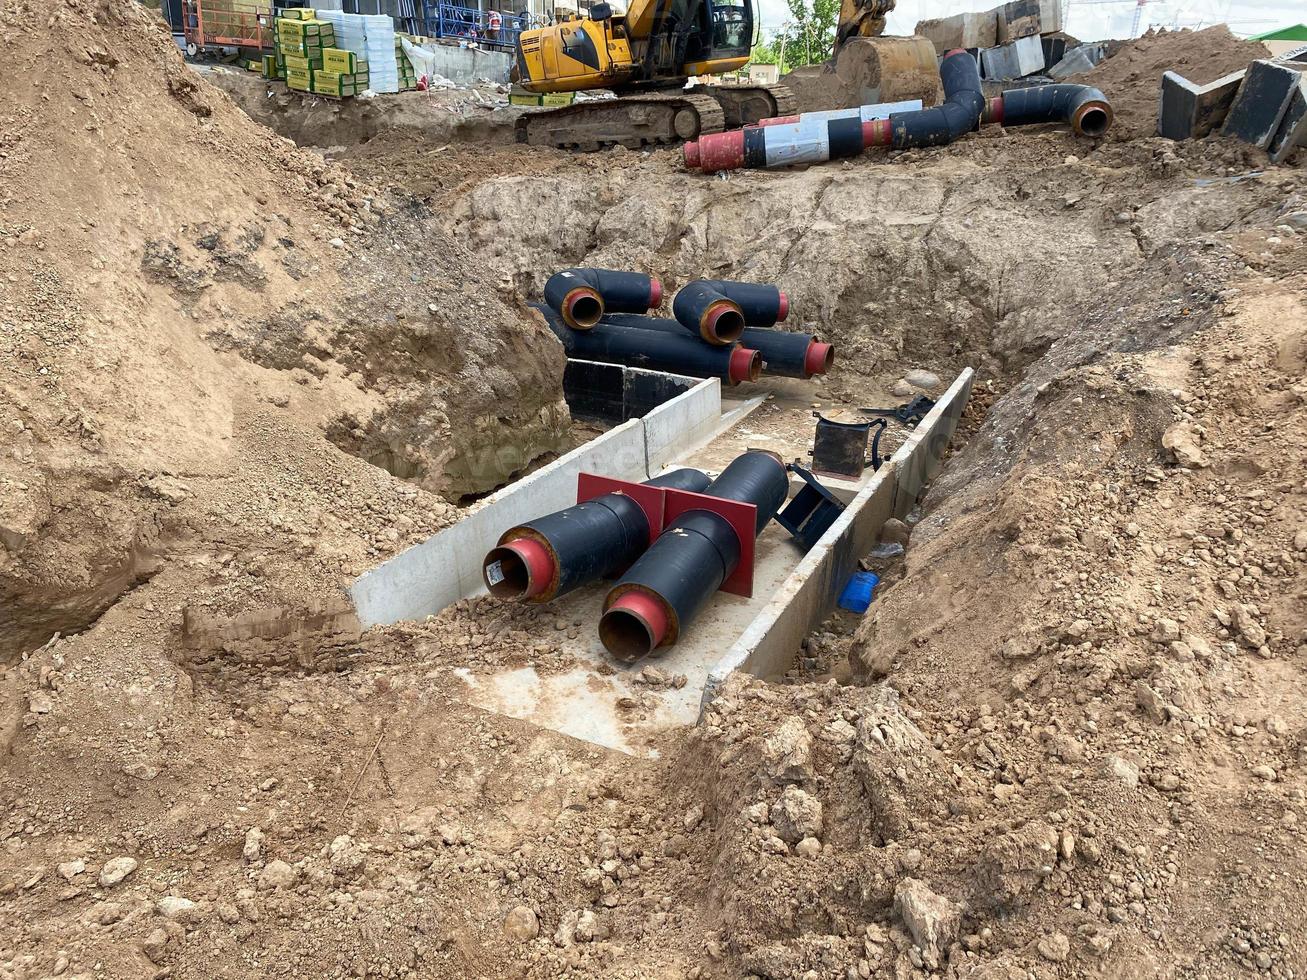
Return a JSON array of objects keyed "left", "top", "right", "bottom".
[{"left": 0, "top": 0, "right": 567, "bottom": 655}]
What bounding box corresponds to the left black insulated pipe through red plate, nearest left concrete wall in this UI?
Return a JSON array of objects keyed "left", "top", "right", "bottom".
[{"left": 481, "top": 469, "right": 711, "bottom": 602}]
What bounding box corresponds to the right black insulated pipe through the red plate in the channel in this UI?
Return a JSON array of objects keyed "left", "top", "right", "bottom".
[{"left": 599, "top": 449, "right": 789, "bottom": 661}]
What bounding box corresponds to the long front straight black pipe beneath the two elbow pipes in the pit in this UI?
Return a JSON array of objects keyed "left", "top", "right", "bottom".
[{"left": 531, "top": 303, "right": 762, "bottom": 385}]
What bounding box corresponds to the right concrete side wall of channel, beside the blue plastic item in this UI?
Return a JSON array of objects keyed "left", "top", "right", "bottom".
[{"left": 703, "top": 368, "right": 972, "bottom": 704}]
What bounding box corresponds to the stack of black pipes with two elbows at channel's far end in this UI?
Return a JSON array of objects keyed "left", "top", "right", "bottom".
[{"left": 531, "top": 269, "right": 835, "bottom": 385}]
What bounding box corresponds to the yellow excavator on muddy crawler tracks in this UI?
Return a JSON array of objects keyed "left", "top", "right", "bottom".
[{"left": 512, "top": 0, "right": 895, "bottom": 150}]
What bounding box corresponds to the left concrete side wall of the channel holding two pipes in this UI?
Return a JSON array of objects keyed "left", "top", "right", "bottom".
[{"left": 349, "top": 378, "right": 721, "bottom": 629}]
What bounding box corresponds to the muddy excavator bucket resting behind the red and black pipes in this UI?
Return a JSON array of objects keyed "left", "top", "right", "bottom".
[{"left": 784, "top": 37, "right": 944, "bottom": 112}]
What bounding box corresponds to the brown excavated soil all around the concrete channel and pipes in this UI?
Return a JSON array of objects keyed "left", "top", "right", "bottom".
[{"left": 0, "top": 11, "right": 1307, "bottom": 980}]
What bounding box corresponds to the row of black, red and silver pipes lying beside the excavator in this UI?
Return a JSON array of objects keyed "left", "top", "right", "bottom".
[{"left": 684, "top": 48, "right": 1112, "bottom": 174}]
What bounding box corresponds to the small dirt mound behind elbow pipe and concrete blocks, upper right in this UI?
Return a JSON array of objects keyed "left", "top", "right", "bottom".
[{"left": 1070, "top": 24, "right": 1270, "bottom": 140}]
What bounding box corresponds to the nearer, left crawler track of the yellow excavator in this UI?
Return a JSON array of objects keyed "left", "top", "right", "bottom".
[{"left": 516, "top": 91, "right": 727, "bottom": 150}]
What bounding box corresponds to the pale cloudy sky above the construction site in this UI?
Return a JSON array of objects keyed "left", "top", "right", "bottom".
[{"left": 758, "top": 0, "right": 1307, "bottom": 41}]
